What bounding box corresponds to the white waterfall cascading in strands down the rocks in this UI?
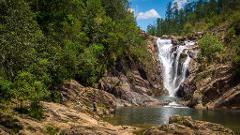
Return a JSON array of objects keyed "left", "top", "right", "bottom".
[{"left": 157, "top": 38, "right": 195, "bottom": 97}]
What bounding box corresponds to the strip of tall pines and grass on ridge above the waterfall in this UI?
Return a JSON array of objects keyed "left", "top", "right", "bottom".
[{"left": 147, "top": 0, "right": 240, "bottom": 36}]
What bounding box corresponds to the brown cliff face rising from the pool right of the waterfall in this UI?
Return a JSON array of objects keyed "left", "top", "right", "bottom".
[{"left": 178, "top": 31, "right": 240, "bottom": 109}]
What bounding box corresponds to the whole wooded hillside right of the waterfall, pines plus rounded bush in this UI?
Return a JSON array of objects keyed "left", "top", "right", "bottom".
[{"left": 147, "top": 0, "right": 240, "bottom": 81}]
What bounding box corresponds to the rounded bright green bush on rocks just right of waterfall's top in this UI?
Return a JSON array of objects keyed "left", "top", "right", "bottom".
[{"left": 198, "top": 33, "right": 224, "bottom": 61}]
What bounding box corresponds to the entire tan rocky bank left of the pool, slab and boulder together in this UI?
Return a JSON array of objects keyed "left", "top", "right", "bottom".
[{"left": 0, "top": 80, "right": 138, "bottom": 135}]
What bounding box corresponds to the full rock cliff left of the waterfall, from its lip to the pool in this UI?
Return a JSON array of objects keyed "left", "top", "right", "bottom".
[{"left": 100, "top": 35, "right": 164, "bottom": 106}]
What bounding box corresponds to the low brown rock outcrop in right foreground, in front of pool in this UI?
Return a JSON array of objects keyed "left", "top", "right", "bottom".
[{"left": 144, "top": 116, "right": 234, "bottom": 135}]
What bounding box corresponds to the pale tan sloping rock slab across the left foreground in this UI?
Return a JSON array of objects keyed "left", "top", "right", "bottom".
[{"left": 0, "top": 102, "right": 136, "bottom": 135}]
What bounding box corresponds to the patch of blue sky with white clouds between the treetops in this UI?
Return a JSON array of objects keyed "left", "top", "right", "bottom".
[{"left": 129, "top": 0, "right": 188, "bottom": 30}]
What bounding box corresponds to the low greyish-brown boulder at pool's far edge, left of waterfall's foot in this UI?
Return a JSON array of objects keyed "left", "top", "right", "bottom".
[{"left": 101, "top": 75, "right": 160, "bottom": 106}]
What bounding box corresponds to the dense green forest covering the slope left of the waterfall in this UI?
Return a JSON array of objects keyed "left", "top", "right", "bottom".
[{"left": 0, "top": 0, "right": 150, "bottom": 118}]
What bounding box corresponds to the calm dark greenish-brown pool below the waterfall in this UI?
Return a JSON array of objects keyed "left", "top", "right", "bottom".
[{"left": 107, "top": 107, "right": 240, "bottom": 135}]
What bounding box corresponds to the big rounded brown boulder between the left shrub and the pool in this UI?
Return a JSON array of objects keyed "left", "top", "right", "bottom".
[{"left": 61, "top": 80, "right": 117, "bottom": 115}]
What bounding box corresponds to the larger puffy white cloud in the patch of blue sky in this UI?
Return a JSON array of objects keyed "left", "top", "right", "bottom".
[{"left": 137, "top": 9, "right": 160, "bottom": 20}]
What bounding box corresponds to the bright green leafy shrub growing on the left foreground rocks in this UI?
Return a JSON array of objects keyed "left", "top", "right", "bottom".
[{"left": 12, "top": 71, "right": 49, "bottom": 119}]
